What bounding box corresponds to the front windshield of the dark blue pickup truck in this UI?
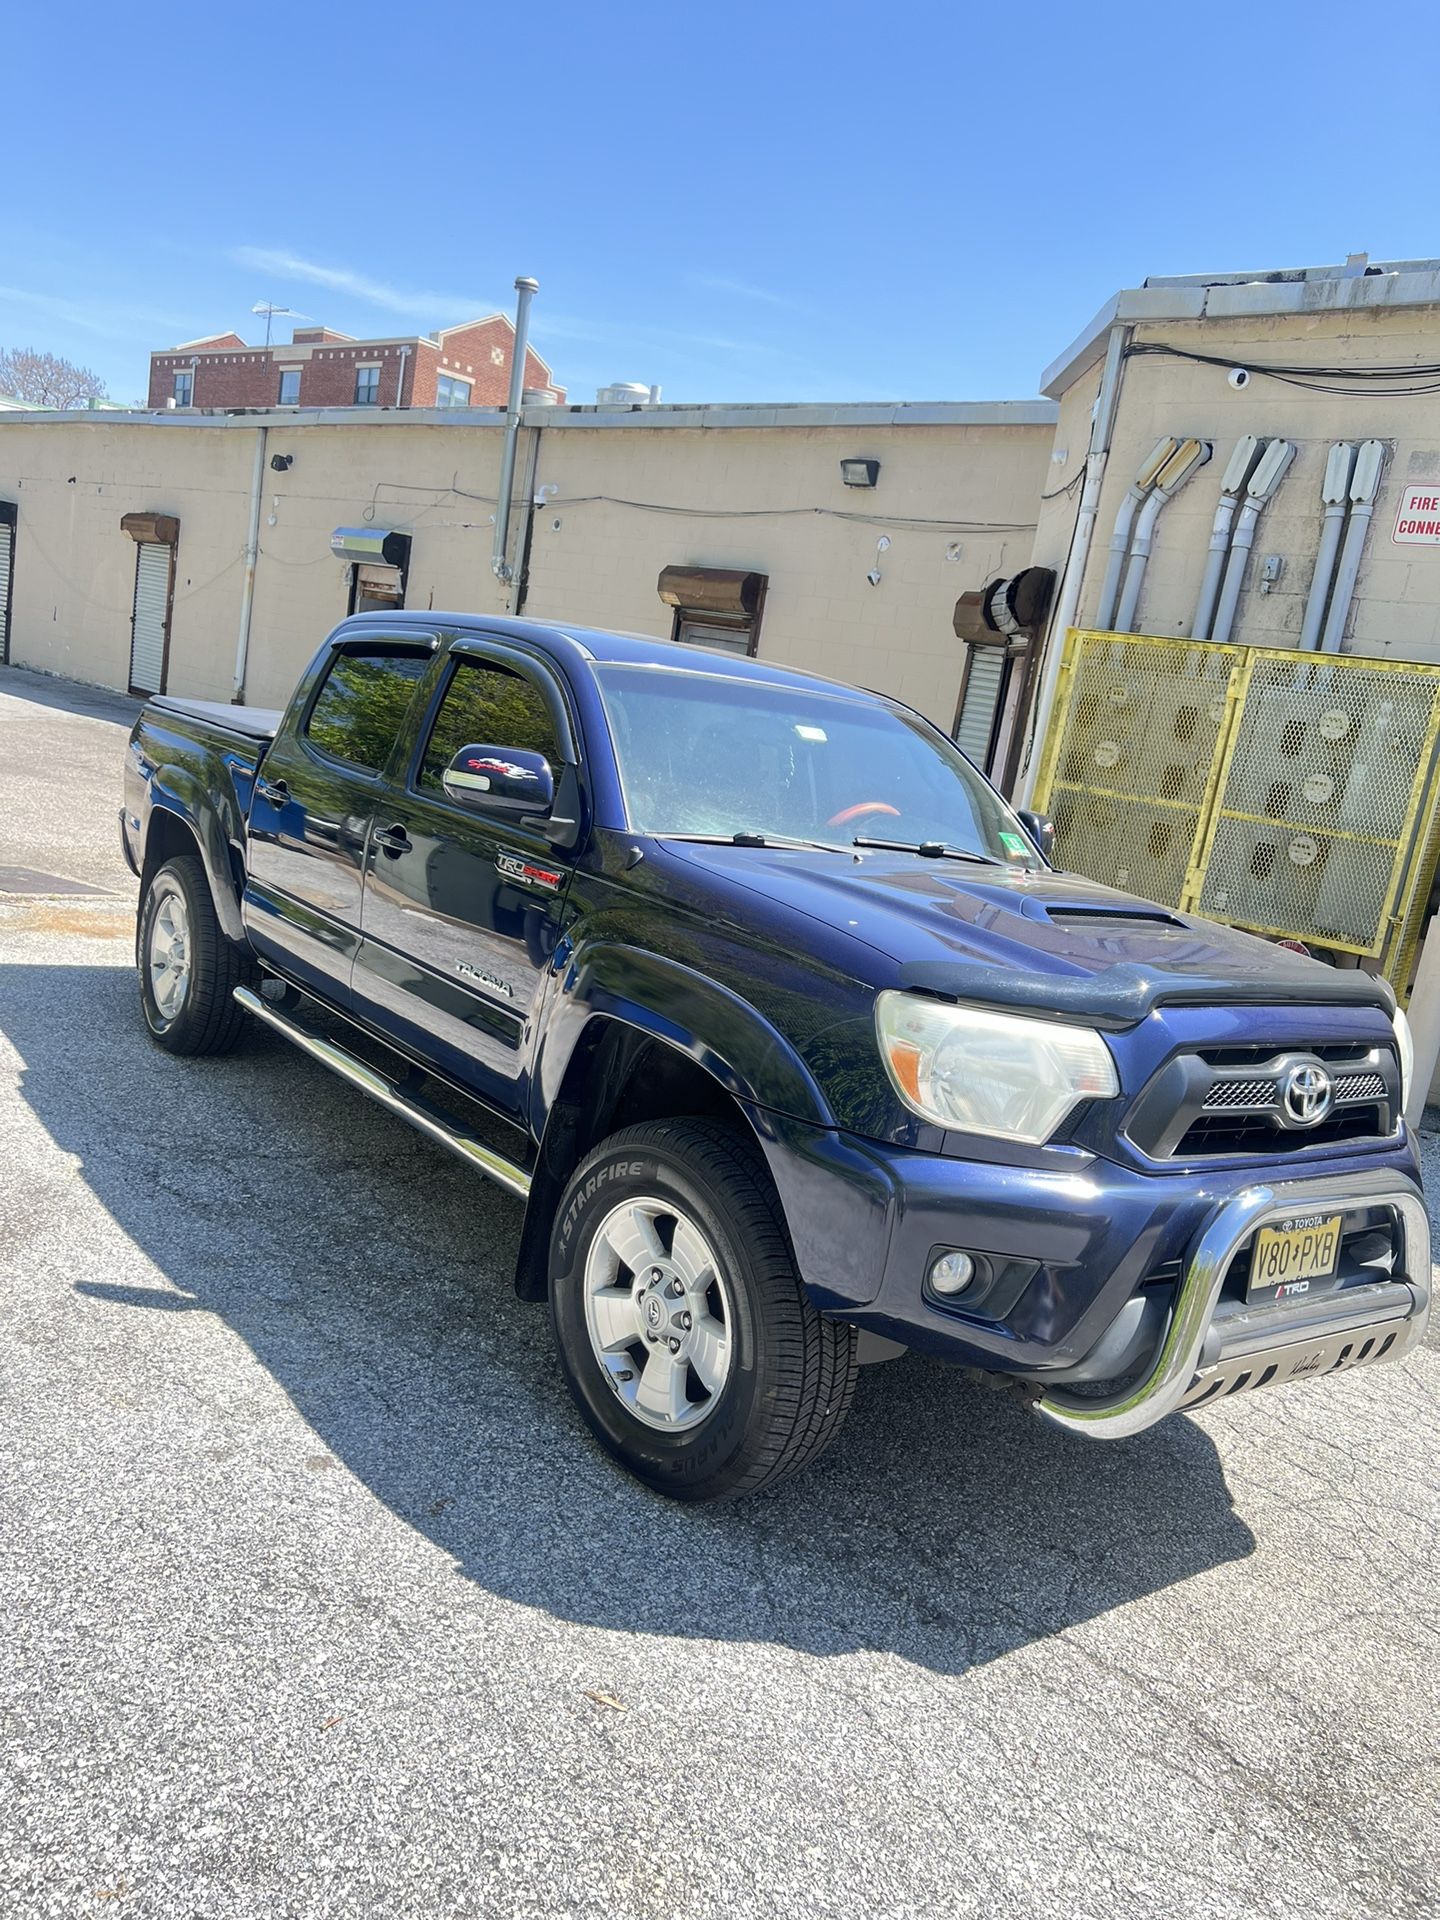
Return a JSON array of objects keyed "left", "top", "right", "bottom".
[{"left": 597, "top": 666, "right": 1041, "bottom": 866}]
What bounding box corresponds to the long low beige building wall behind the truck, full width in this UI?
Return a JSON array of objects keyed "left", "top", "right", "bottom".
[{"left": 0, "top": 419, "right": 1052, "bottom": 728}]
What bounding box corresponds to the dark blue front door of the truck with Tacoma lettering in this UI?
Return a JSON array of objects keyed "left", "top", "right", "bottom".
[{"left": 353, "top": 643, "right": 574, "bottom": 1116}]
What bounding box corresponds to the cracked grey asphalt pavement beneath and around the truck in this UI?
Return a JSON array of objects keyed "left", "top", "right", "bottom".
[{"left": 0, "top": 670, "right": 1440, "bottom": 1920}]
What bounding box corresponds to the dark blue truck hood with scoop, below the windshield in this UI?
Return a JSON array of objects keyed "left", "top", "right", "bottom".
[{"left": 666, "top": 841, "right": 1394, "bottom": 1023}]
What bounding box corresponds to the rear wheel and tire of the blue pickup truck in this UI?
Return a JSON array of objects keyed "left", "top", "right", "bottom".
[{"left": 134, "top": 854, "right": 253, "bottom": 1054}]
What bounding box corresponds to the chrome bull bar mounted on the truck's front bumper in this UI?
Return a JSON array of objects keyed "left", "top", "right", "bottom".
[{"left": 1033, "top": 1169, "right": 1430, "bottom": 1440}]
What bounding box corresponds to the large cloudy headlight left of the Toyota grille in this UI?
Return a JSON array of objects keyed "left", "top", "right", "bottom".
[{"left": 876, "top": 993, "right": 1119, "bottom": 1144}]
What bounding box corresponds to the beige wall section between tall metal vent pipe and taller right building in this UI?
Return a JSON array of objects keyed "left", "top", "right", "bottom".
[{"left": 526, "top": 426, "right": 1050, "bottom": 728}]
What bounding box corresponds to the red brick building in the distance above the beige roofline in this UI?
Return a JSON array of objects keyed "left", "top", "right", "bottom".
[{"left": 150, "top": 313, "right": 564, "bottom": 409}]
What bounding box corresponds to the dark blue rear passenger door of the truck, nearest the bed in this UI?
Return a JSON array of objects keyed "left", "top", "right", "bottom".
[{"left": 244, "top": 634, "right": 436, "bottom": 1008}]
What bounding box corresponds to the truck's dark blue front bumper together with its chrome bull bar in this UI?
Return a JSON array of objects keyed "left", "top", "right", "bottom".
[{"left": 756, "top": 1116, "right": 1430, "bottom": 1438}]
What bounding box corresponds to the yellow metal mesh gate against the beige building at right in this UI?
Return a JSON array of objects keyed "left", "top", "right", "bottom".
[{"left": 1037, "top": 630, "right": 1440, "bottom": 989}]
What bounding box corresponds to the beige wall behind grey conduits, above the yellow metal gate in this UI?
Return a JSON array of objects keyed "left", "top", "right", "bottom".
[{"left": 1067, "top": 309, "right": 1440, "bottom": 660}]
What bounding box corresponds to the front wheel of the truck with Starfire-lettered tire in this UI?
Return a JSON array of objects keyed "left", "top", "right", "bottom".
[{"left": 551, "top": 1119, "right": 856, "bottom": 1501}]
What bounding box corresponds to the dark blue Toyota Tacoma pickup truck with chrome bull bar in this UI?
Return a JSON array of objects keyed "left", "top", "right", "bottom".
[{"left": 121, "top": 612, "right": 1430, "bottom": 1500}]
